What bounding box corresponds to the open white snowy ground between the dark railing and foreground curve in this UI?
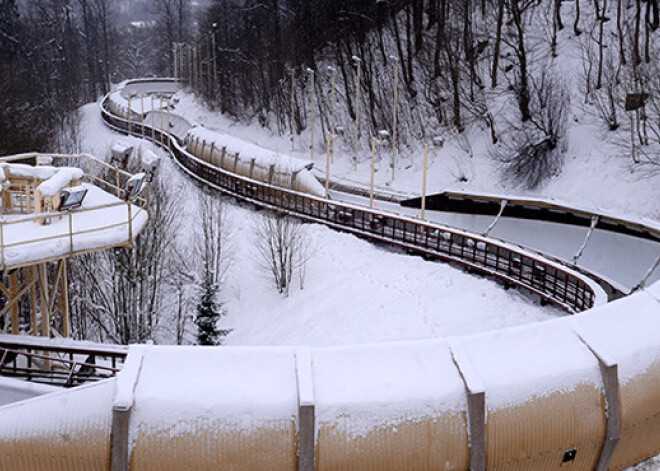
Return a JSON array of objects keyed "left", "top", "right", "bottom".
[{"left": 81, "top": 95, "right": 563, "bottom": 345}]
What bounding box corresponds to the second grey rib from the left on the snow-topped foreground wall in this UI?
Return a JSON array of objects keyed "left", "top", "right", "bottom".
[{"left": 296, "top": 347, "right": 316, "bottom": 471}]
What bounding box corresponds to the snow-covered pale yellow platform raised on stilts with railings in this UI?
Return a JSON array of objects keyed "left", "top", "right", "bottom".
[{"left": 0, "top": 153, "right": 149, "bottom": 337}]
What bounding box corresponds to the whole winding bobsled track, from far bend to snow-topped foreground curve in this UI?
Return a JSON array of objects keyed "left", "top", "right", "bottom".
[{"left": 0, "top": 79, "right": 660, "bottom": 471}]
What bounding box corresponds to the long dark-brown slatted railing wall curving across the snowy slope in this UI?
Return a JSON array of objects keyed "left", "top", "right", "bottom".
[{"left": 101, "top": 91, "right": 608, "bottom": 313}]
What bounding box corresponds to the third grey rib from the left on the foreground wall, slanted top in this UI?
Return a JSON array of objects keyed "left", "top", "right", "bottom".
[{"left": 449, "top": 342, "right": 488, "bottom": 471}]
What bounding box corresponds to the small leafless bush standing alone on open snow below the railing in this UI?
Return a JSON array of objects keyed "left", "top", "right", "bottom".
[{"left": 256, "top": 214, "right": 312, "bottom": 297}]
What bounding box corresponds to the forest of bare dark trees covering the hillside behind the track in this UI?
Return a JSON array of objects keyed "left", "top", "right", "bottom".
[{"left": 0, "top": 0, "right": 660, "bottom": 187}]
